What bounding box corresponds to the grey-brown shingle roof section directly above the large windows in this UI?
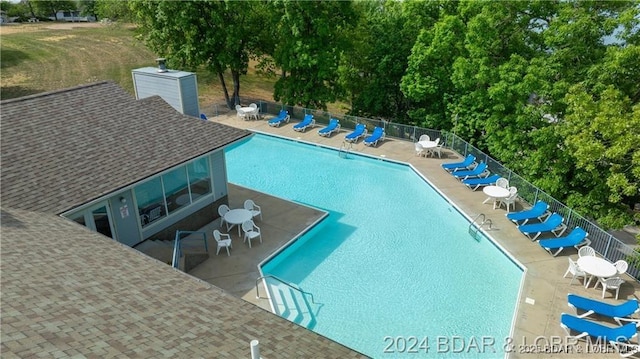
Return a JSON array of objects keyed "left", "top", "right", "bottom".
[{"left": 0, "top": 82, "right": 250, "bottom": 213}]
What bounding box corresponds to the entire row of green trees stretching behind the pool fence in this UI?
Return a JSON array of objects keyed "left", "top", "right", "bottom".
[{"left": 127, "top": 0, "right": 640, "bottom": 231}]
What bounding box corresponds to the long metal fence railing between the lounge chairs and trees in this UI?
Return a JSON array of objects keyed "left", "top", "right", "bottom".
[{"left": 214, "top": 101, "right": 640, "bottom": 280}]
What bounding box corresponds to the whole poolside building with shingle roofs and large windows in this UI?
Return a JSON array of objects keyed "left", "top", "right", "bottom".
[{"left": 0, "top": 82, "right": 361, "bottom": 358}]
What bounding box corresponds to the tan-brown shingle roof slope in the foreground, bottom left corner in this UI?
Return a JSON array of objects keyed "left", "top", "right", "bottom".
[{"left": 0, "top": 208, "right": 364, "bottom": 358}]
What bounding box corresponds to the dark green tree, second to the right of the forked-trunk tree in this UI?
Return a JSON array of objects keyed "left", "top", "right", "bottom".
[{"left": 340, "top": 0, "right": 420, "bottom": 122}]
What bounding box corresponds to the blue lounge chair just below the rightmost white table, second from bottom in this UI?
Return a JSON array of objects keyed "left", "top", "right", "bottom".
[{"left": 567, "top": 294, "right": 640, "bottom": 325}]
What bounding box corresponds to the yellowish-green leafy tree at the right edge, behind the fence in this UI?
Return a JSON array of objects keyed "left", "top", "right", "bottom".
[{"left": 560, "top": 85, "right": 640, "bottom": 228}]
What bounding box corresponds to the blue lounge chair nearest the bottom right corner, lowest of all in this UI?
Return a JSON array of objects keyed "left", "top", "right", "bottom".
[{"left": 560, "top": 313, "right": 638, "bottom": 357}]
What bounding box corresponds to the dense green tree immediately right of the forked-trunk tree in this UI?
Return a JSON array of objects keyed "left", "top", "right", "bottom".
[{"left": 272, "top": 0, "right": 356, "bottom": 109}]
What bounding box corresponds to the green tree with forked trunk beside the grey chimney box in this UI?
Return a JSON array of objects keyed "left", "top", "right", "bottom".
[{"left": 129, "top": 0, "right": 264, "bottom": 108}]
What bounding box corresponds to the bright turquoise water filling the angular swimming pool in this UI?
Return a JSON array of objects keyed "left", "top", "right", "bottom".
[{"left": 226, "top": 135, "right": 522, "bottom": 358}]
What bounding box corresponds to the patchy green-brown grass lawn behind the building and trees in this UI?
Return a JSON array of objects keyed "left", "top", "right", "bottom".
[{"left": 0, "top": 23, "right": 275, "bottom": 107}]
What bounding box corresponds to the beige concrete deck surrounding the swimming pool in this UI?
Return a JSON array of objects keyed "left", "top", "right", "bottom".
[{"left": 180, "top": 114, "right": 640, "bottom": 358}]
